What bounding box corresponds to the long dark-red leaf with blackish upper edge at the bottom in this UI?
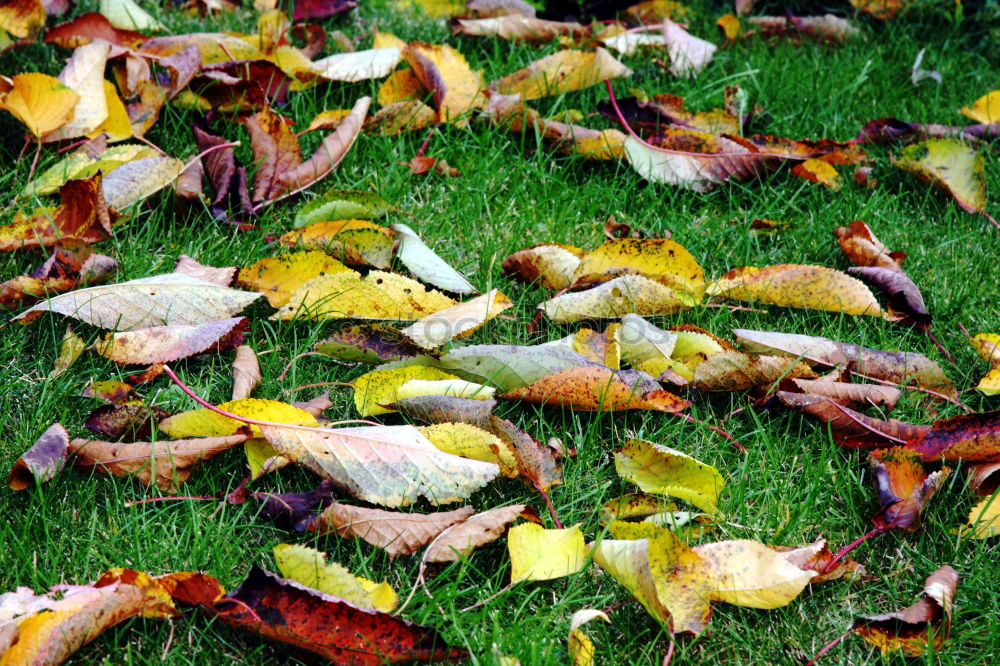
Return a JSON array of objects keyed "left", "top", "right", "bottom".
[{"left": 211, "top": 566, "right": 468, "bottom": 666}]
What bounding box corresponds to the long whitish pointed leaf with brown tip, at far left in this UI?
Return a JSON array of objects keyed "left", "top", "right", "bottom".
[{"left": 14, "top": 273, "right": 260, "bottom": 330}]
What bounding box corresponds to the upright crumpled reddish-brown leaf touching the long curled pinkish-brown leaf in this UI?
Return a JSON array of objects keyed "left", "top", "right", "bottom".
[{"left": 246, "top": 109, "right": 302, "bottom": 201}]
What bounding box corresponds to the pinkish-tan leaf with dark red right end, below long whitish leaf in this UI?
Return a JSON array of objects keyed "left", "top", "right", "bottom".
[{"left": 94, "top": 317, "right": 250, "bottom": 365}]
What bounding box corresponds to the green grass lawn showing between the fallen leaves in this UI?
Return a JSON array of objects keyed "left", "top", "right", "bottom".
[{"left": 0, "top": 2, "right": 1000, "bottom": 666}]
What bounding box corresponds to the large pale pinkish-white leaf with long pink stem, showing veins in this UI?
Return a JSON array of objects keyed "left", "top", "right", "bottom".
[{"left": 260, "top": 425, "right": 500, "bottom": 506}]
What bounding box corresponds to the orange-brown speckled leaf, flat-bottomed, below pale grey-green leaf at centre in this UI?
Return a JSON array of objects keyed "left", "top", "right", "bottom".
[{"left": 501, "top": 366, "right": 691, "bottom": 412}]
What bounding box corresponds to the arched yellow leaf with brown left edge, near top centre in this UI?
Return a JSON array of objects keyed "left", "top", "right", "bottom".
[{"left": 404, "top": 43, "right": 484, "bottom": 127}]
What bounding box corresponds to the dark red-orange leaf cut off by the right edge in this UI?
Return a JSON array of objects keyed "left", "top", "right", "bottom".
[{"left": 906, "top": 411, "right": 1000, "bottom": 462}]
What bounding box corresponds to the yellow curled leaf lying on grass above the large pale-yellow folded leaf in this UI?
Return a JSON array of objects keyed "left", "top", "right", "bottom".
[{"left": 615, "top": 439, "right": 725, "bottom": 513}]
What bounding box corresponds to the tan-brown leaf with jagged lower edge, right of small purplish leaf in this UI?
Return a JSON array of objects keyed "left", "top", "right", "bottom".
[{"left": 69, "top": 434, "right": 250, "bottom": 492}]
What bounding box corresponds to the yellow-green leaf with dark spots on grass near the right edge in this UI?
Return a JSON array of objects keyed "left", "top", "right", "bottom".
[{"left": 892, "top": 139, "right": 986, "bottom": 218}]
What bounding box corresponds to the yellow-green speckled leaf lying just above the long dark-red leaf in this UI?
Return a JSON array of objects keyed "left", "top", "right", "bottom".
[{"left": 274, "top": 543, "right": 399, "bottom": 613}]
